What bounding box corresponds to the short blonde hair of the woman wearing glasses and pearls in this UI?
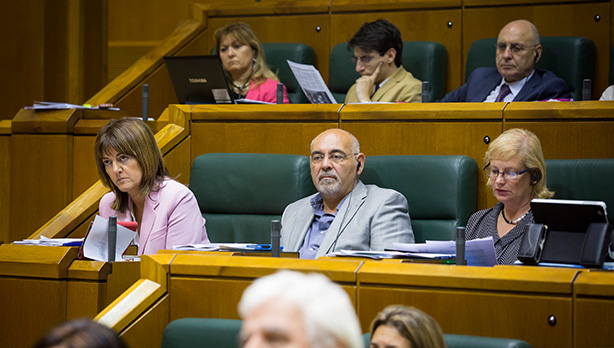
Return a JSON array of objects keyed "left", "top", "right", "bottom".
[{"left": 484, "top": 128, "right": 554, "bottom": 198}]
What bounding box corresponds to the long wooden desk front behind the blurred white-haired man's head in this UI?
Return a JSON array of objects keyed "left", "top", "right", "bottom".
[{"left": 103, "top": 253, "right": 614, "bottom": 348}]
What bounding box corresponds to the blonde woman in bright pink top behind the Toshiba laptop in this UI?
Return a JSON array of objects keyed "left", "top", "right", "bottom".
[{"left": 215, "top": 23, "right": 289, "bottom": 104}]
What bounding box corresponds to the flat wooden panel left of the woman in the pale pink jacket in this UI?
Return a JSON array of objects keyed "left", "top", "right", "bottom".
[{"left": 9, "top": 134, "right": 72, "bottom": 241}]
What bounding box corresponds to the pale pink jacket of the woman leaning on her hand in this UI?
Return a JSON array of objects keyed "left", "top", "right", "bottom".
[{"left": 98, "top": 178, "right": 209, "bottom": 255}]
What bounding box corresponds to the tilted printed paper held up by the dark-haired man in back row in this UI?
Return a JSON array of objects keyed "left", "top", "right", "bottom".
[{"left": 287, "top": 60, "right": 337, "bottom": 104}]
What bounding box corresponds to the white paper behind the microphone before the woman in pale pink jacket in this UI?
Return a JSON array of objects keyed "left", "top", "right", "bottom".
[{"left": 83, "top": 215, "right": 136, "bottom": 261}]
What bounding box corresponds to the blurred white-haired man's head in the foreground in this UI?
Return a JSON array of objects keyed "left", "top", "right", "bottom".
[{"left": 239, "top": 271, "right": 363, "bottom": 348}]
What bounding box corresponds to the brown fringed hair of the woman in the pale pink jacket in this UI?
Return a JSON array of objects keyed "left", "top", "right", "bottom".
[{"left": 94, "top": 118, "right": 170, "bottom": 213}]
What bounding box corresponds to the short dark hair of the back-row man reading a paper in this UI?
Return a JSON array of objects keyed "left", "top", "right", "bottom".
[{"left": 348, "top": 19, "right": 403, "bottom": 67}]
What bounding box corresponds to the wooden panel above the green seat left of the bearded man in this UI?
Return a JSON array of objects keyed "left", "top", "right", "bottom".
[{"left": 192, "top": 104, "right": 340, "bottom": 157}]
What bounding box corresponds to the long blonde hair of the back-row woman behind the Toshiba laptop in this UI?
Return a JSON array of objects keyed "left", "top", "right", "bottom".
[{"left": 214, "top": 22, "right": 279, "bottom": 85}]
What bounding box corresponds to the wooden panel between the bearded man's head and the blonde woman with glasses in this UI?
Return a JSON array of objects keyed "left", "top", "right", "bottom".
[{"left": 341, "top": 103, "right": 503, "bottom": 210}]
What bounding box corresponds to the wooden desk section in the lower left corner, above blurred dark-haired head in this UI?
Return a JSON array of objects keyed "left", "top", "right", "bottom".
[{"left": 0, "top": 244, "right": 139, "bottom": 348}]
